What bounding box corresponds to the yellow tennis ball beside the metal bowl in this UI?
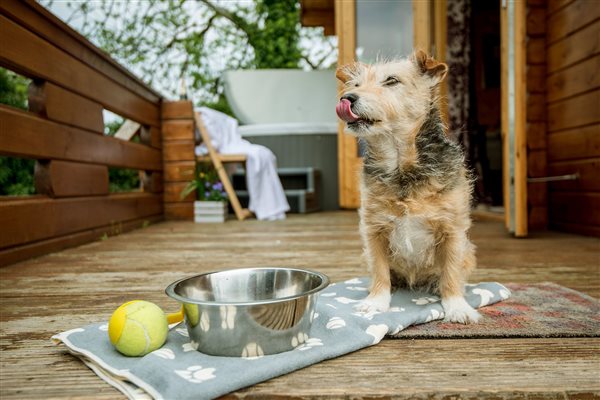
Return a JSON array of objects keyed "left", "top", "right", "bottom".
[{"left": 108, "top": 300, "right": 169, "bottom": 357}]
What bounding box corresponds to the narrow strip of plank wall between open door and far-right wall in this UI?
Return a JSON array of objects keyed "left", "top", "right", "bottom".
[{"left": 526, "top": 0, "right": 548, "bottom": 230}]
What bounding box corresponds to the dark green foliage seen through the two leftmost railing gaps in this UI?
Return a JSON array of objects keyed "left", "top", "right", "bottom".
[{"left": 0, "top": 68, "right": 35, "bottom": 196}]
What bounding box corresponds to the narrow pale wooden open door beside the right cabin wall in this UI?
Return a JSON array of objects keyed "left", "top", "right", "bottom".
[{"left": 500, "top": 0, "right": 528, "bottom": 237}]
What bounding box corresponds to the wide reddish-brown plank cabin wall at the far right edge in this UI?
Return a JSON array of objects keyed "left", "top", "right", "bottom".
[{"left": 546, "top": 0, "right": 600, "bottom": 236}]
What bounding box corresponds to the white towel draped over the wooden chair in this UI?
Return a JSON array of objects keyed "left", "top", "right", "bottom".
[{"left": 196, "top": 107, "right": 290, "bottom": 220}]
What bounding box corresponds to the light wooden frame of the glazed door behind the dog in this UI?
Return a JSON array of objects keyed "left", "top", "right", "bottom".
[{"left": 335, "top": 0, "right": 447, "bottom": 208}]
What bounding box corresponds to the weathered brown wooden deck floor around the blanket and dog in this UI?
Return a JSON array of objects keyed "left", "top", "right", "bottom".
[{"left": 0, "top": 212, "right": 600, "bottom": 399}]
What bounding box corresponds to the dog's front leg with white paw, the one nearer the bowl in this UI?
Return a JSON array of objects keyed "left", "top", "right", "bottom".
[{"left": 355, "top": 230, "right": 392, "bottom": 313}]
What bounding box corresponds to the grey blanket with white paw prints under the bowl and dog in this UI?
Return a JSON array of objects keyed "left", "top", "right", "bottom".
[{"left": 52, "top": 278, "right": 510, "bottom": 400}]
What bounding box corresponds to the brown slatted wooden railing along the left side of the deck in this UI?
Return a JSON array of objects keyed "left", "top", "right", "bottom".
[{"left": 0, "top": 0, "right": 163, "bottom": 265}]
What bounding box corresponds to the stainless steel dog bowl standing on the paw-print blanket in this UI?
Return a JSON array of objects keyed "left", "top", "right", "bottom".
[{"left": 165, "top": 268, "right": 329, "bottom": 357}]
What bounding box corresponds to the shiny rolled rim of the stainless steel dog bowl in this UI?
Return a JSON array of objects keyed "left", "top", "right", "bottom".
[{"left": 165, "top": 267, "right": 329, "bottom": 306}]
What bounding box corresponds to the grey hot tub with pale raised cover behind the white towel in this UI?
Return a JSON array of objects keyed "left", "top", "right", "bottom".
[{"left": 224, "top": 69, "right": 339, "bottom": 210}]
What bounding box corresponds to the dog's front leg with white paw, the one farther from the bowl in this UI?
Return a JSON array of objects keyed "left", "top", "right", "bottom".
[{"left": 436, "top": 232, "right": 480, "bottom": 324}]
